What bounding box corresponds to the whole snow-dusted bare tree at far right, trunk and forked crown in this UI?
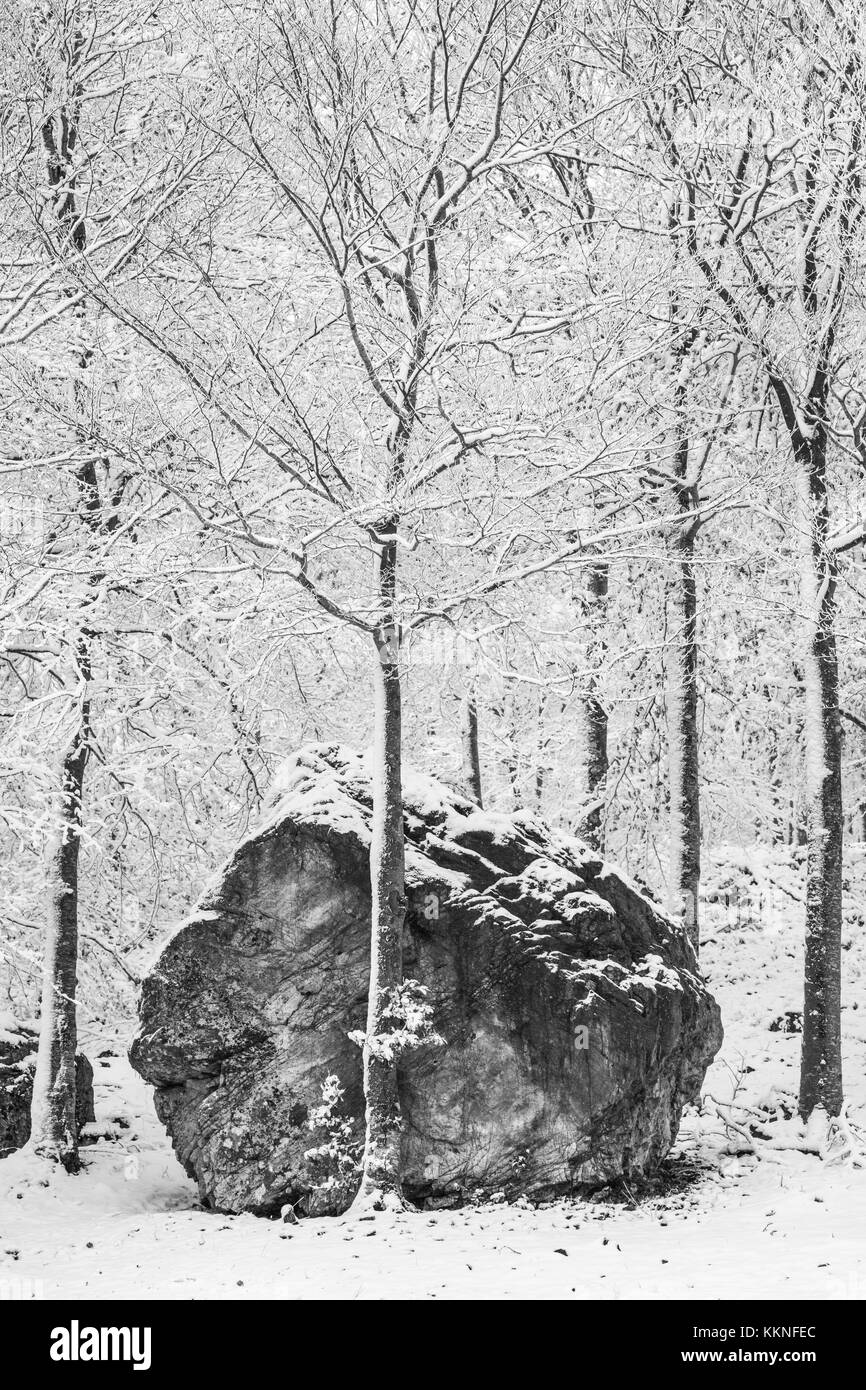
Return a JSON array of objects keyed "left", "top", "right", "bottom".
[{"left": 617, "top": 0, "right": 863, "bottom": 1116}]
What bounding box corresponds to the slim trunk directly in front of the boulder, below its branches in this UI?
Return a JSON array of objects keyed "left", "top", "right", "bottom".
[{"left": 353, "top": 520, "right": 406, "bottom": 1211}]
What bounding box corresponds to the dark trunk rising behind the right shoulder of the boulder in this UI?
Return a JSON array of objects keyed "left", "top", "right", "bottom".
[{"left": 666, "top": 517, "right": 701, "bottom": 951}]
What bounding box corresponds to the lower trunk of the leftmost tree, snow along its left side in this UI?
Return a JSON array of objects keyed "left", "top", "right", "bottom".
[{"left": 31, "top": 700, "right": 90, "bottom": 1173}]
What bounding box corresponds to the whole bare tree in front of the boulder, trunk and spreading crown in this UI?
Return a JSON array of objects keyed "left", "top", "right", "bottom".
[{"left": 83, "top": 0, "right": 556, "bottom": 1209}]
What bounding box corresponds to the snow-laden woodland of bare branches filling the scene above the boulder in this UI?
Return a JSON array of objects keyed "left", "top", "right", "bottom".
[{"left": 0, "top": 0, "right": 866, "bottom": 1178}]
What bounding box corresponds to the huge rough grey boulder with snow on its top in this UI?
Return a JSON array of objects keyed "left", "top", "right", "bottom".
[{"left": 131, "top": 746, "right": 721, "bottom": 1213}]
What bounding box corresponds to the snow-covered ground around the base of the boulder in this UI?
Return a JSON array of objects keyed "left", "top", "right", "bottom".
[{"left": 0, "top": 847, "right": 866, "bottom": 1300}]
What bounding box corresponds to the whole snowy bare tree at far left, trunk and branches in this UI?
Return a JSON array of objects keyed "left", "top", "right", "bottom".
[{"left": 0, "top": 0, "right": 201, "bottom": 1172}]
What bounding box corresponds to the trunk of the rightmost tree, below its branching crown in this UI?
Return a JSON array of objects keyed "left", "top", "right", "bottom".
[{"left": 799, "top": 442, "right": 842, "bottom": 1119}]
